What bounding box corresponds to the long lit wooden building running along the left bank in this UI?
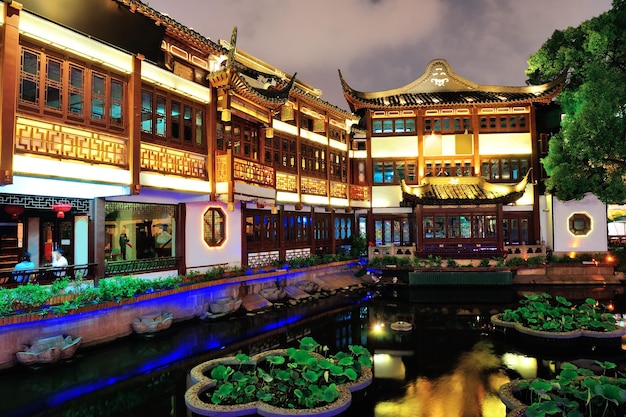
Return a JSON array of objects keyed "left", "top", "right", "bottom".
[{"left": 0, "top": 0, "right": 360, "bottom": 276}]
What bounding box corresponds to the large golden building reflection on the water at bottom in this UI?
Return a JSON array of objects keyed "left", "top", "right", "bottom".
[{"left": 375, "top": 342, "right": 510, "bottom": 417}]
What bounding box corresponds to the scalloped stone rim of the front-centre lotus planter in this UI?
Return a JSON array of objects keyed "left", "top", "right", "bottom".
[{"left": 185, "top": 349, "right": 373, "bottom": 417}]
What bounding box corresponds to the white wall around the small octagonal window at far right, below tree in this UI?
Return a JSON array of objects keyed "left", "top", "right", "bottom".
[{"left": 552, "top": 193, "right": 608, "bottom": 253}]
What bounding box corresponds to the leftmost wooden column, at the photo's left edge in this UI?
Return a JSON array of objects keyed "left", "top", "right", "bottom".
[{"left": 0, "top": 2, "right": 22, "bottom": 184}]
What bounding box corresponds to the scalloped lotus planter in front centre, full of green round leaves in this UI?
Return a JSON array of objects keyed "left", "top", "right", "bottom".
[{"left": 185, "top": 337, "right": 372, "bottom": 417}]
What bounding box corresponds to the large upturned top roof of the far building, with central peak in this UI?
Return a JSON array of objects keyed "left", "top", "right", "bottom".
[{"left": 339, "top": 59, "right": 567, "bottom": 112}]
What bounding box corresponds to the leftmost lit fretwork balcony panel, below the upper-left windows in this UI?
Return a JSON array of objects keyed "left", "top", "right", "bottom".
[{"left": 15, "top": 117, "right": 128, "bottom": 167}]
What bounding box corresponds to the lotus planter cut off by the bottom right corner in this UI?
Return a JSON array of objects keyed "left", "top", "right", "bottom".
[{"left": 498, "top": 361, "right": 626, "bottom": 417}]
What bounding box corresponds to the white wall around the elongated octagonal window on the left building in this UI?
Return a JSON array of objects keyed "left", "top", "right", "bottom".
[{"left": 185, "top": 202, "right": 241, "bottom": 268}]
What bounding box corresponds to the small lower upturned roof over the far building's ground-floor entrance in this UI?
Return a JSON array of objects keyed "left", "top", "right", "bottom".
[{"left": 402, "top": 170, "right": 530, "bottom": 207}]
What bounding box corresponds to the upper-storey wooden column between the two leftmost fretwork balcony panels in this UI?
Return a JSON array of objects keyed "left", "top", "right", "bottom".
[{"left": 128, "top": 55, "right": 143, "bottom": 194}]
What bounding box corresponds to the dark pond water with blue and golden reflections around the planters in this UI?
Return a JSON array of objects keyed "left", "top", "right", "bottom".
[{"left": 0, "top": 286, "right": 626, "bottom": 417}]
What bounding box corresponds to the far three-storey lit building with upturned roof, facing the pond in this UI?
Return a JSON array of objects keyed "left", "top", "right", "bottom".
[{"left": 339, "top": 59, "right": 601, "bottom": 257}]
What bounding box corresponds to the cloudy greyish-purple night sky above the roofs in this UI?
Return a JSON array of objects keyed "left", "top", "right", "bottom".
[{"left": 144, "top": 0, "right": 611, "bottom": 109}]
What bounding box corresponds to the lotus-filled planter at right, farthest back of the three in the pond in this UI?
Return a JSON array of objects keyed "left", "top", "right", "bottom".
[{"left": 491, "top": 293, "right": 626, "bottom": 350}]
